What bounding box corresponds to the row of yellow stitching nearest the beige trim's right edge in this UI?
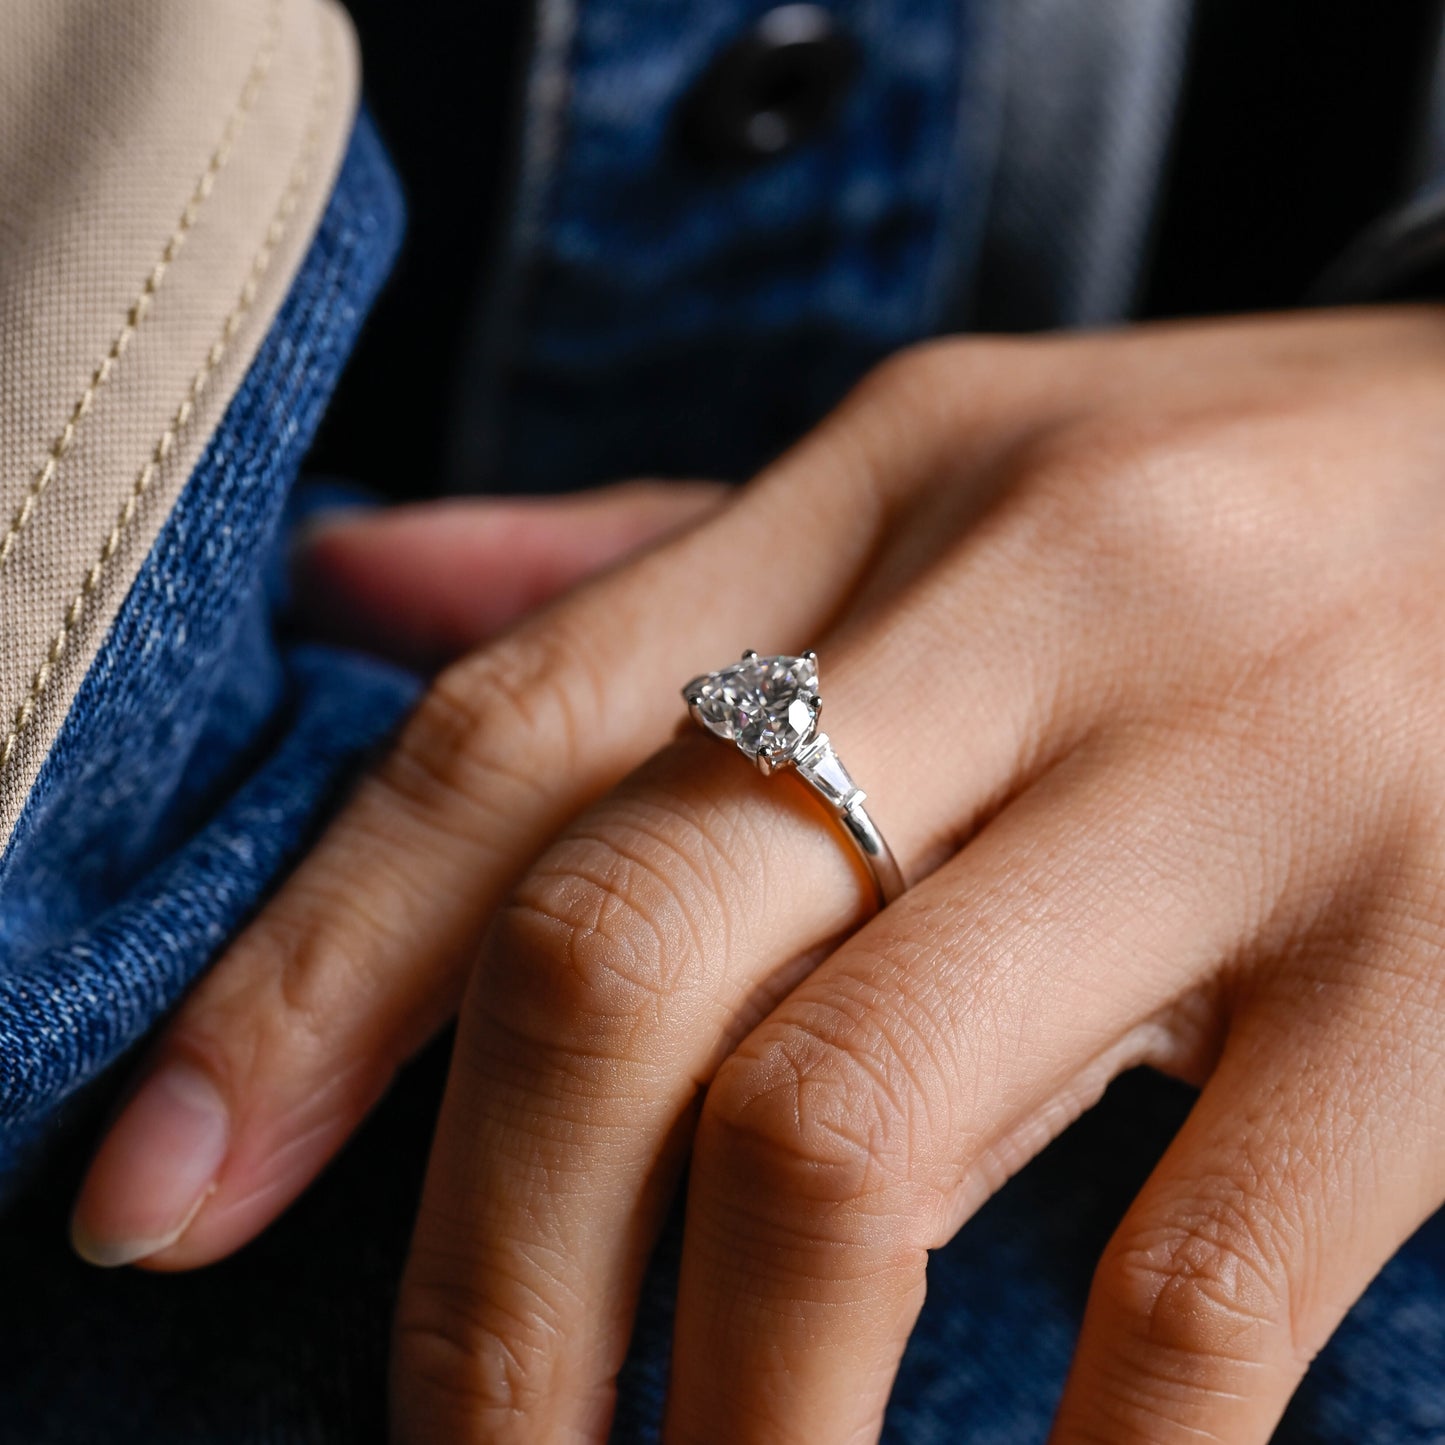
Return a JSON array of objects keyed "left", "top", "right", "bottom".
[{"left": 0, "top": 0, "right": 337, "bottom": 769}]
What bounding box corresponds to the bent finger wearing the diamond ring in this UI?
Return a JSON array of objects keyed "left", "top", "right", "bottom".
[{"left": 394, "top": 471, "right": 1260, "bottom": 1441}]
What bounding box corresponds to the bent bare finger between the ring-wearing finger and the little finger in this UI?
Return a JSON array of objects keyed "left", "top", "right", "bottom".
[{"left": 666, "top": 743, "right": 1288, "bottom": 1445}]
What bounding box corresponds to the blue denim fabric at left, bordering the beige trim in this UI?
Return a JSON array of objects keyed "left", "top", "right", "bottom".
[{"left": 0, "top": 109, "right": 415, "bottom": 1189}]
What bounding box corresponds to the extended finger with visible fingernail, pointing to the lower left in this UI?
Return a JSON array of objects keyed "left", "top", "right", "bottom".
[{"left": 75, "top": 343, "right": 1045, "bottom": 1267}]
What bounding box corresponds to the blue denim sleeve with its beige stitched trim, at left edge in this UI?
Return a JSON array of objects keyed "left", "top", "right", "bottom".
[{"left": 0, "top": 0, "right": 413, "bottom": 1194}]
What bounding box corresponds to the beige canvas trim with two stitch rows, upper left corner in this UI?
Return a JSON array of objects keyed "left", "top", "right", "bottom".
[{"left": 0, "top": 0, "right": 357, "bottom": 841}]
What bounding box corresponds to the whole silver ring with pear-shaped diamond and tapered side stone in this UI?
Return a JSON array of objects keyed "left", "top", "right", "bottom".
[{"left": 682, "top": 652, "right": 907, "bottom": 907}]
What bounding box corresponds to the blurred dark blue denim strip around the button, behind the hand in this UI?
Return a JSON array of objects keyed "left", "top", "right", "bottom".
[{"left": 455, "top": 0, "right": 998, "bottom": 491}]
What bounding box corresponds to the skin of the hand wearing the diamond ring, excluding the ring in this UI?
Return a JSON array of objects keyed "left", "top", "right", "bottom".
[{"left": 77, "top": 308, "right": 1445, "bottom": 1445}]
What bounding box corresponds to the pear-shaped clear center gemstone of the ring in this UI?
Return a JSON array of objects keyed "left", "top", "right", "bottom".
[{"left": 682, "top": 656, "right": 819, "bottom": 762}]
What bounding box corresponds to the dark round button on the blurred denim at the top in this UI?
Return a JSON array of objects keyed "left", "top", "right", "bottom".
[{"left": 679, "top": 4, "right": 858, "bottom": 168}]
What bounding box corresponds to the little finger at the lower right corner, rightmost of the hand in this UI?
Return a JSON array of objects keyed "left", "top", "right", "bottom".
[{"left": 1051, "top": 926, "right": 1445, "bottom": 1445}]
